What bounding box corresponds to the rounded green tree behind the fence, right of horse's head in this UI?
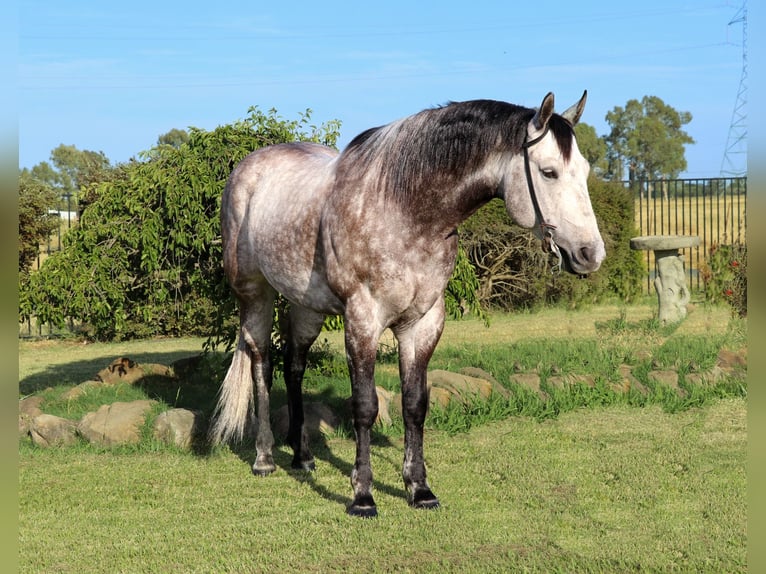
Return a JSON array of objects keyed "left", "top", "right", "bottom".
[{"left": 606, "top": 96, "right": 694, "bottom": 184}]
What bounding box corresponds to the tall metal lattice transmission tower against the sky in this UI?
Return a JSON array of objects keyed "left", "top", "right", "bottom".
[{"left": 721, "top": 1, "right": 747, "bottom": 177}]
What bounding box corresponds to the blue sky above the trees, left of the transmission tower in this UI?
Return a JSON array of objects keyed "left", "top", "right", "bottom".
[{"left": 17, "top": 0, "right": 752, "bottom": 177}]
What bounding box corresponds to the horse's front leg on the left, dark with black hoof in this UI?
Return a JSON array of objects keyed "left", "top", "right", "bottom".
[{"left": 345, "top": 311, "right": 380, "bottom": 518}]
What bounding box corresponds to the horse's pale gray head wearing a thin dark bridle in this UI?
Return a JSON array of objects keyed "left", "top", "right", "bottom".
[{"left": 505, "top": 93, "right": 606, "bottom": 274}]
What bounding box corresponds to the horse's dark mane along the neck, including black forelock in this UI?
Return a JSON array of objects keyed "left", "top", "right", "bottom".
[{"left": 338, "top": 100, "right": 574, "bottom": 207}]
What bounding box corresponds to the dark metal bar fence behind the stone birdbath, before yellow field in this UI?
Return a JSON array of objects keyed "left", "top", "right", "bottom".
[{"left": 625, "top": 177, "right": 747, "bottom": 291}]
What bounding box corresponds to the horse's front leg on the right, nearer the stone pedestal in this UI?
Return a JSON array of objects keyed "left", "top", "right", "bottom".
[{"left": 394, "top": 300, "right": 444, "bottom": 508}]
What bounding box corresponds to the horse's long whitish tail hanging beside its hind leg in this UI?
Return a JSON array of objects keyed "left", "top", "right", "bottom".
[{"left": 208, "top": 336, "right": 255, "bottom": 444}]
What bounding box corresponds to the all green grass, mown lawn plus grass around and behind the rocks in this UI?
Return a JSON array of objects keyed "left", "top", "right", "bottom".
[{"left": 19, "top": 302, "right": 747, "bottom": 572}]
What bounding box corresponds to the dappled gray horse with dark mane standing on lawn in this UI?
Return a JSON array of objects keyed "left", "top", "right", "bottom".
[{"left": 210, "top": 93, "right": 605, "bottom": 516}]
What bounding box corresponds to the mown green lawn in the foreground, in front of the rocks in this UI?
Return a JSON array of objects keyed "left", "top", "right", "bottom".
[{"left": 19, "top": 399, "right": 746, "bottom": 573}]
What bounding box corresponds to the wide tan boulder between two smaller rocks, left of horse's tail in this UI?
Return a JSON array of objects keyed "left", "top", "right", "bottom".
[{"left": 77, "top": 400, "right": 157, "bottom": 446}]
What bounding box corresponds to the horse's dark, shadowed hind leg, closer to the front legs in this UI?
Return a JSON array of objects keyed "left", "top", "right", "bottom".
[{"left": 283, "top": 305, "right": 325, "bottom": 470}]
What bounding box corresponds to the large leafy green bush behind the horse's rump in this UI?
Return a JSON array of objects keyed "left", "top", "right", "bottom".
[{"left": 19, "top": 108, "right": 338, "bottom": 340}]
